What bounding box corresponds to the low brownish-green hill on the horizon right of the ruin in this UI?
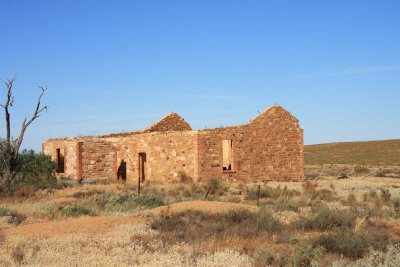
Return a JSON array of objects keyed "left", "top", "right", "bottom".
[{"left": 304, "top": 139, "right": 400, "bottom": 166}]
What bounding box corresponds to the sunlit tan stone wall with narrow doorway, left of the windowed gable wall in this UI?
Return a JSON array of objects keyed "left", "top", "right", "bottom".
[{"left": 110, "top": 131, "right": 198, "bottom": 183}]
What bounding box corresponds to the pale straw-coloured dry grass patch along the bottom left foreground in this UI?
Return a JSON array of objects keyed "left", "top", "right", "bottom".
[{"left": 0, "top": 225, "right": 253, "bottom": 266}]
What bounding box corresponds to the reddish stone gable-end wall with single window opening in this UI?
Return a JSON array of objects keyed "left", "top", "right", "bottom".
[{"left": 199, "top": 106, "right": 304, "bottom": 181}]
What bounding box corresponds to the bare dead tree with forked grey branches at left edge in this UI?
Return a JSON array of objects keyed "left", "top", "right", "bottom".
[{"left": 0, "top": 74, "right": 47, "bottom": 190}]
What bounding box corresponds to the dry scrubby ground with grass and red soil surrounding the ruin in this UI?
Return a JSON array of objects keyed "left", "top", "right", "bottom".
[{"left": 0, "top": 141, "right": 400, "bottom": 266}]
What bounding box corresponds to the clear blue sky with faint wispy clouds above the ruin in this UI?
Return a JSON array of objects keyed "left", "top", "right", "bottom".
[{"left": 0, "top": 0, "right": 400, "bottom": 150}]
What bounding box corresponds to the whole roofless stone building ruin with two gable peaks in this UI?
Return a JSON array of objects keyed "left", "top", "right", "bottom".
[{"left": 42, "top": 105, "right": 304, "bottom": 183}]
